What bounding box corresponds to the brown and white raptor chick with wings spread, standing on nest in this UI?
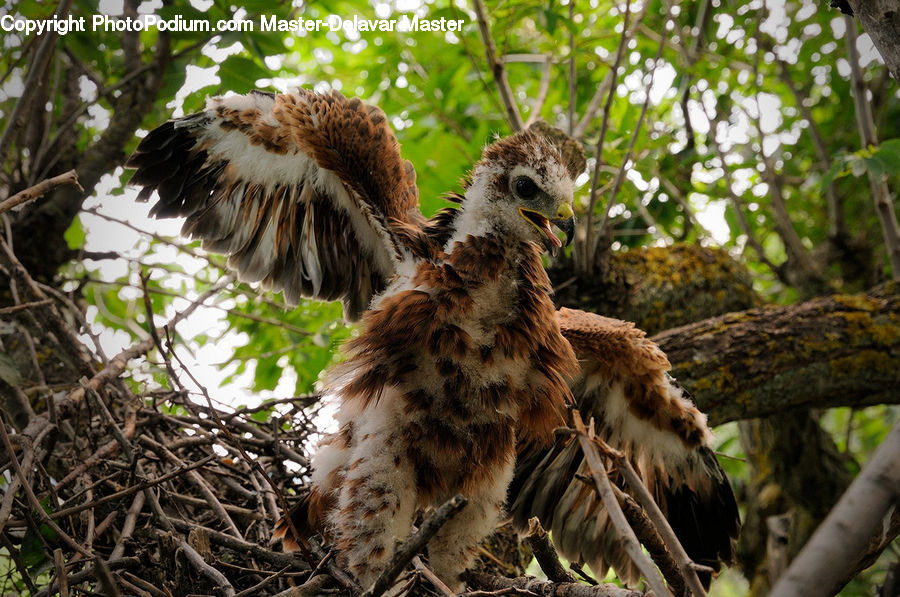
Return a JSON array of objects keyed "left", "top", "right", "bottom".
[{"left": 126, "top": 88, "right": 737, "bottom": 591}]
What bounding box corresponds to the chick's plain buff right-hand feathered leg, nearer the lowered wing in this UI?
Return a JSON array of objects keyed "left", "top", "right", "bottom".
[{"left": 428, "top": 455, "right": 514, "bottom": 592}]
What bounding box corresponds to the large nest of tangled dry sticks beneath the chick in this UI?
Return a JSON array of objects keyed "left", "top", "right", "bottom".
[{"left": 0, "top": 225, "right": 641, "bottom": 597}]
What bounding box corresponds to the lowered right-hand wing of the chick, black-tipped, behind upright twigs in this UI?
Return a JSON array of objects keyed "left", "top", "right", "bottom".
[{"left": 509, "top": 309, "right": 740, "bottom": 584}]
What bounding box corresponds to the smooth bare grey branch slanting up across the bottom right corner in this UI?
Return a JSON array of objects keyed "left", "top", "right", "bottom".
[{"left": 770, "top": 424, "right": 900, "bottom": 597}]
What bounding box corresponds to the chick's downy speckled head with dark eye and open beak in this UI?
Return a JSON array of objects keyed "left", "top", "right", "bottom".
[{"left": 463, "top": 131, "right": 575, "bottom": 254}]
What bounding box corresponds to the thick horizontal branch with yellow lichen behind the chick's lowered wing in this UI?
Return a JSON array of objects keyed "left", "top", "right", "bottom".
[{"left": 654, "top": 284, "right": 900, "bottom": 425}]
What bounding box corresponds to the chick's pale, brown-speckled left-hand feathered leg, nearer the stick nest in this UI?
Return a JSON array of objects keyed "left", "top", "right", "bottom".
[{"left": 331, "top": 428, "right": 416, "bottom": 588}]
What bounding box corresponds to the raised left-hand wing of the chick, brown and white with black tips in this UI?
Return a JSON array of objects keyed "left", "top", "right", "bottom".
[{"left": 127, "top": 89, "right": 424, "bottom": 319}]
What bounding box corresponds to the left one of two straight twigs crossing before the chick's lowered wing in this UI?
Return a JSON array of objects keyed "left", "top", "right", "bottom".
[{"left": 572, "top": 410, "right": 670, "bottom": 597}]
